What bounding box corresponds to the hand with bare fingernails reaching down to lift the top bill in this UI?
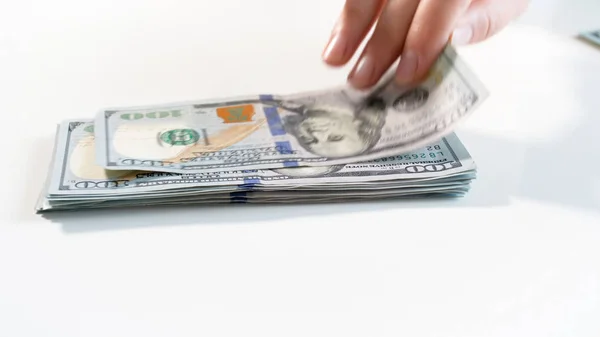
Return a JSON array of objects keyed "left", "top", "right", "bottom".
[{"left": 323, "top": 0, "right": 528, "bottom": 89}]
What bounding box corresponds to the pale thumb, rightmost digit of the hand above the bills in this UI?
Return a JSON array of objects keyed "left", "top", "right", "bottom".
[{"left": 451, "top": 0, "right": 527, "bottom": 45}]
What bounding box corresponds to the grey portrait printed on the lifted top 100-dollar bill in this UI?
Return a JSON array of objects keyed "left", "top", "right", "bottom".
[{"left": 268, "top": 92, "right": 387, "bottom": 158}]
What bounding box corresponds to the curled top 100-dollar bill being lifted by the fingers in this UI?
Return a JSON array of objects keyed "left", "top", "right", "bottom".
[{"left": 94, "top": 47, "right": 488, "bottom": 173}]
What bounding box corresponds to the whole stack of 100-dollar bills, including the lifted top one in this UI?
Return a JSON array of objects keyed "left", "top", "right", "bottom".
[{"left": 36, "top": 47, "right": 488, "bottom": 212}]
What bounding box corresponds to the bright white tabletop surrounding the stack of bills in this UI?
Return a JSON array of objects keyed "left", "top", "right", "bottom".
[{"left": 0, "top": 0, "right": 600, "bottom": 337}]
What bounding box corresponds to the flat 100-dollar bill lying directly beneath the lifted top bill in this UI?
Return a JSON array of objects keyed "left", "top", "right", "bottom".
[{"left": 45, "top": 120, "right": 475, "bottom": 200}]
